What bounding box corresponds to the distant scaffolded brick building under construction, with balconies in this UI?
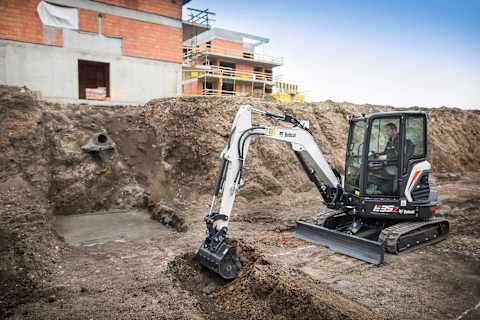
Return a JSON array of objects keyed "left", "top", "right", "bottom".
[{"left": 182, "top": 28, "right": 298, "bottom": 97}]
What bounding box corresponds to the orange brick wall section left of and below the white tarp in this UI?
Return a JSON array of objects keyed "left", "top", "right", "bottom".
[{"left": 0, "top": 0, "right": 63, "bottom": 46}]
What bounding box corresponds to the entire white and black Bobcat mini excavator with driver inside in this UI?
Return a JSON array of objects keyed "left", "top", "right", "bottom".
[{"left": 196, "top": 105, "right": 449, "bottom": 279}]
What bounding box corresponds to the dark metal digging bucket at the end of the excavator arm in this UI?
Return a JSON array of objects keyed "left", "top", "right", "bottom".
[{"left": 197, "top": 242, "right": 241, "bottom": 280}]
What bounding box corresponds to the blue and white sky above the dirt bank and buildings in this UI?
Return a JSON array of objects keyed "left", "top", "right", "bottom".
[{"left": 185, "top": 0, "right": 480, "bottom": 109}]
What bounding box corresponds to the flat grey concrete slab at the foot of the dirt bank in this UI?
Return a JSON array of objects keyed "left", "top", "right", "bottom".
[{"left": 55, "top": 210, "right": 173, "bottom": 246}]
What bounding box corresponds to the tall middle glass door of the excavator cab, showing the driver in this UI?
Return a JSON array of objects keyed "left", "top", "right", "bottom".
[{"left": 364, "top": 115, "right": 402, "bottom": 197}]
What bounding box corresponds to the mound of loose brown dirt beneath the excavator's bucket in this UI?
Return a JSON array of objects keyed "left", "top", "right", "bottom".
[{"left": 170, "top": 240, "right": 380, "bottom": 320}]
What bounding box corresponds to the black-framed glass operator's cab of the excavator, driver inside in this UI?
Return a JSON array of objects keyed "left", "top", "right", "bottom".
[{"left": 344, "top": 112, "right": 430, "bottom": 208}]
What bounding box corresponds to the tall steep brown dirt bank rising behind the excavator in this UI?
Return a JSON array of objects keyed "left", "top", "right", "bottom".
[{"left": 0, "top": 87, "right": 480, "bottom": 214}]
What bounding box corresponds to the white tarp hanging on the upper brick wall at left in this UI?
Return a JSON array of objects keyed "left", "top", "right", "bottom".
[{"left": 37, "top": 1, "right": 78, "bottom": 30}]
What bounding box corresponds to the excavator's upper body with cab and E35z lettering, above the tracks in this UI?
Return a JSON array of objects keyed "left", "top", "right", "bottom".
[{"left": 343, "top": 112, "right": 437, "bottom": 220}]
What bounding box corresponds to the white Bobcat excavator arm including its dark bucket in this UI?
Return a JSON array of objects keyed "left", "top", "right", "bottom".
[{"left": 197, "top": 105, "right": 343, "bottom": 279}]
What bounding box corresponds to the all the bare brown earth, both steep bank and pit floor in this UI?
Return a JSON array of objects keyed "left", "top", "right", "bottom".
[{"left": 0, "top": 87, "right": 480, "bottom": 319}]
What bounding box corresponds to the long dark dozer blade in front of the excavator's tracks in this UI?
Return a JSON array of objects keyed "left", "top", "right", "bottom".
[{"left": 296, "top": 221, "right": 385, "bottom": 264}]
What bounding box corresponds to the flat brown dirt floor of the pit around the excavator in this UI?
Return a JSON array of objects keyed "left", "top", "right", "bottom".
[{"left": 5, "top": 178, "right": 480, "bottom": 320}]
